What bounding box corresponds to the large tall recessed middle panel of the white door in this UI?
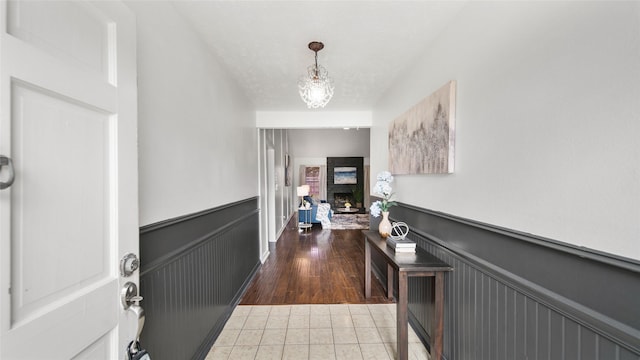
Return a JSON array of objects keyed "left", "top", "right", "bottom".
[{"left": 11, "top": 83, "right": 110, "bottom": 322}]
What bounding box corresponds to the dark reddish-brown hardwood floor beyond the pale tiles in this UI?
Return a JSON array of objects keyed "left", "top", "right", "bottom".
[{"left": 240, "top": 217, "right": 392, "bottom": 305}]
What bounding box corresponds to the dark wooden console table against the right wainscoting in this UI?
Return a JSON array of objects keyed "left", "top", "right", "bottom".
[{"left": 362, "top": 230, "right": 453, "bottom": 360}]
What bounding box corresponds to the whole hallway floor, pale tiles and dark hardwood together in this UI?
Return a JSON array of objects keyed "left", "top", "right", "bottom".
[{"left": 206, "top": 218, "right": 429, "bottom": 360}]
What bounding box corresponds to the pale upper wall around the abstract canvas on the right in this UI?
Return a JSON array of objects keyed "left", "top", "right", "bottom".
[{"left": 371, "top": 2, "right": 640, "bottom": 259}]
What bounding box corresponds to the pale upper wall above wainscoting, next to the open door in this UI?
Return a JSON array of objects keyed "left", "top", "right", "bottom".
[{"left": 127, "top": 1, "right": 258, "bottom": 225}]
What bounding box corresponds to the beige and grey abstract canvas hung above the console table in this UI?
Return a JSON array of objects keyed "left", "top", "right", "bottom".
[{"left": 389, "top": 81, "right": 456, "bottom": 174}]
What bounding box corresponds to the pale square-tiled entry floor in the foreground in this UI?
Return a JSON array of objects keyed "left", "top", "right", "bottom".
[{"left": 206, "top": 304, "right": 429, "bottom": 360}]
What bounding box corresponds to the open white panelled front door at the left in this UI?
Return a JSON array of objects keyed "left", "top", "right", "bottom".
[{"left": 0, "top": 1, "right": 139, "bottom": 359}]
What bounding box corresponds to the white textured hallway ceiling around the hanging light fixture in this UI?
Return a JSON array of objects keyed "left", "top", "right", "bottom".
[{"left": 173, "top": 0, "right": 465, "bottom": 111}]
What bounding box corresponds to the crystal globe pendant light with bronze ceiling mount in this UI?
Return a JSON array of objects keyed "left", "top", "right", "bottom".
[{"left": 298, "top": 41, "right": 335, "bottom": 109}]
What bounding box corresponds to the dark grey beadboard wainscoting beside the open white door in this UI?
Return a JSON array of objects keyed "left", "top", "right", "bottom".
[{"left": 140, "top": 198, "right": 260, "bottom": 360}]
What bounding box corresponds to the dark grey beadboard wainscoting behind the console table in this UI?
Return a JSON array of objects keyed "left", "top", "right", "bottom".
[{"left": 372, "top": 204, "right": 640, "bottom": 360}]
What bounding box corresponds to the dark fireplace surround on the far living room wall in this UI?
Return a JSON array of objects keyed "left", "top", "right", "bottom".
[{"left": 327, "top": 157, "right": 364, "bottom": 209}]
